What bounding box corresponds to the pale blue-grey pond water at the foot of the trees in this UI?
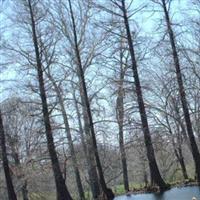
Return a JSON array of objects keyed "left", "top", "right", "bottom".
[{"left": 115, "top": 186, "right": 200, "bottom": 200}]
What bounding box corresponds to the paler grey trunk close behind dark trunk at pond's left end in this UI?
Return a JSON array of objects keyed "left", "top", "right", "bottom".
[{"left": 73, "top": 87, "right": 100, "bottom": 199}]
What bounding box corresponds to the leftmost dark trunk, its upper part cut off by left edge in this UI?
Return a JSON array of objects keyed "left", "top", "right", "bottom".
[{"left": 0, "top": 110, "right": 17, "bottom": 200}]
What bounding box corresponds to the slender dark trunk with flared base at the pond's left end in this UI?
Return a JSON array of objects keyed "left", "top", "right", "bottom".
[{"left": 68, "top": 0, "right": 114, "bottom": 199}]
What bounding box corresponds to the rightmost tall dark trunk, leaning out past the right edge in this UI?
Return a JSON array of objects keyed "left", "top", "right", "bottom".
[{"left": 162, "top": 0, "right": 200, "bottom": 184}]
